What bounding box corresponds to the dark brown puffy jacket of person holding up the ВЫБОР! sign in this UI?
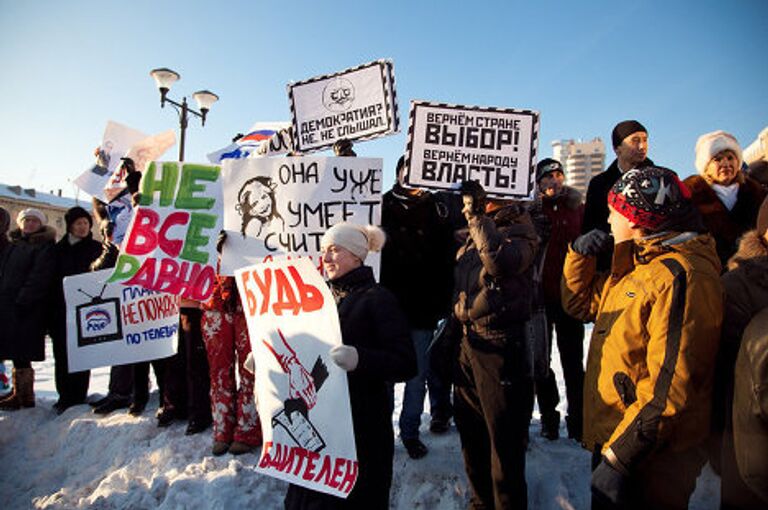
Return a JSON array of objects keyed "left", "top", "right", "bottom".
[{"left": 453, "top": 205, "right": 539, "bottom": 336}]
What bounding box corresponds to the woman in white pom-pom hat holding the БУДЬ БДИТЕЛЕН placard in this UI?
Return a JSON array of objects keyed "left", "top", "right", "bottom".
[{"left": 285, "top": 223, "right": 416, "bottom": 510}]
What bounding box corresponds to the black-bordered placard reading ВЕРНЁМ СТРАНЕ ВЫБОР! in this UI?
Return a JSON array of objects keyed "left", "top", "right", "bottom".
[{"left": 405, "top": 101, "right": 539, "bottom": 199}]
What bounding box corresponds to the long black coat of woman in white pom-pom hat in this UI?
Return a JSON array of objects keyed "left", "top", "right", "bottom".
[{"left": 285, "top": 266, "right": 416, "bottom": 510}]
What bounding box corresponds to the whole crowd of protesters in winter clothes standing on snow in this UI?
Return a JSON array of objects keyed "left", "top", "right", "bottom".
[{"left": 0, "top": 120, "right": 768, "bottom": 509}]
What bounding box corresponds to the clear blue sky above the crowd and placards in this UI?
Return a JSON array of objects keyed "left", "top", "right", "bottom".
[{"left": 0, "top": 0, "right": 768, "bottom": 196}]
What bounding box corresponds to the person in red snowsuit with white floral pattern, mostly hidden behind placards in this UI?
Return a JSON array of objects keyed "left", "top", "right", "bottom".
[{"left": 202, "top": 233, "right": 262, "bottom": 455}]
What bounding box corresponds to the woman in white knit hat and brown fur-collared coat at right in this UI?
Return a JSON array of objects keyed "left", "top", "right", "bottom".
[{"left": 683, "top": 131, "right": 765, "bottom": 270}]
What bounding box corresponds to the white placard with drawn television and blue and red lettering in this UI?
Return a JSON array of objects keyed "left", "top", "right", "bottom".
[{"left": 64, "top": 269, "right": 179, "bottom": 372}]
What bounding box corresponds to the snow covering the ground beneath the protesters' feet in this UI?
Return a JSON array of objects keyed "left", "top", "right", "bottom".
[{"left": 0, "top": 336, "right": 720, "bottom": 510}]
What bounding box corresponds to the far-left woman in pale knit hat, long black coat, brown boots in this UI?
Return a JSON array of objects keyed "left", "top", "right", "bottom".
[{"left": 0, "top": 208, "right": 56, "bottom": 410}]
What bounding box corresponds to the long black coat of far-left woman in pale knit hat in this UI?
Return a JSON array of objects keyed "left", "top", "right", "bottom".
[{"left": 0, "top": 226, "right": 56, "bottom": 361}]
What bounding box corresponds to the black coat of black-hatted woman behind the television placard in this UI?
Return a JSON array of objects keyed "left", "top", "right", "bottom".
[{"left": 50, "top": 233, "right": 101, "bottom": 338}]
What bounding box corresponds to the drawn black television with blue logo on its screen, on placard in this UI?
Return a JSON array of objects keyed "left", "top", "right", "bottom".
[{"left": 75, "top": 284, "right": 123, "bottom": 347}]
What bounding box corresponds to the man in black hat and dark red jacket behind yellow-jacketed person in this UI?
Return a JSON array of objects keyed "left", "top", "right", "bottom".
[{"left": 530, "top": 158, "right": 584, "bottom": 441}]
